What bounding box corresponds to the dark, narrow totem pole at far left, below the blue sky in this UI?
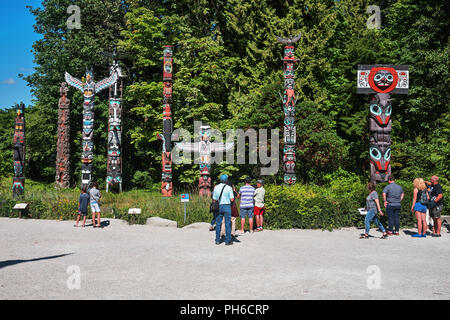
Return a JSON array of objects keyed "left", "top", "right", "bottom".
[{"left": 12, "top": 103, "right": 25, "bottom": 197}]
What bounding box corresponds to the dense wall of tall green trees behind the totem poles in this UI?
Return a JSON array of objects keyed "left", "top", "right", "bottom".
[{"left": 0, "top": 0, "right": 450, "bottom": 188}]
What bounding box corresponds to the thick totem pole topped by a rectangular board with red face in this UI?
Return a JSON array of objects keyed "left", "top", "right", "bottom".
[{"left": 356, "top": 64, "right": 409, "bottom": 183}]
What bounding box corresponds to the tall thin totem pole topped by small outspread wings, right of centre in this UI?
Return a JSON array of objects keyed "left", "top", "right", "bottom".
[{"left": 277, "top": 33, "right": 301, "bottom": 185}]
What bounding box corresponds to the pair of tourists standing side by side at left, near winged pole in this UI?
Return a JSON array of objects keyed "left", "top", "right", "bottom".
[{"left": 74, "top": 182, "right": 102, "bottom": 228}]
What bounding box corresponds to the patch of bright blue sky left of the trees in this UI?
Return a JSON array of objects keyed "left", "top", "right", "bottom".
[{"left": 0, "top": 0, "right": 42, "bottom": 109}]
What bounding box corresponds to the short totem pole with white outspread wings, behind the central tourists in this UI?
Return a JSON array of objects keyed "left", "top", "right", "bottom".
[{"left": 176, "top": 125, "right": 234, "bottom": 197}]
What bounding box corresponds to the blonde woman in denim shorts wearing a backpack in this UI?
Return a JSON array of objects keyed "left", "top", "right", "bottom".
[{"left": 411, "top": 178, "right": 430, "bottom": 238}]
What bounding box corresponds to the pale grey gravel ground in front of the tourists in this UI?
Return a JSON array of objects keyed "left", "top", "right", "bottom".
[{"left": 0, "top": 218, "right": 450, "bottom": 300}]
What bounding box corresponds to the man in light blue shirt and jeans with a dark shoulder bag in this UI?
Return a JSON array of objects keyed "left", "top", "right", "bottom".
[{"left": 213, "top": 174, "right": 234, "bottom": 246}]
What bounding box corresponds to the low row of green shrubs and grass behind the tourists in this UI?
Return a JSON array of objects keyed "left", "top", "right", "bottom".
[{"left": 0, "top": 174, "right": 450, "bottom": 230}]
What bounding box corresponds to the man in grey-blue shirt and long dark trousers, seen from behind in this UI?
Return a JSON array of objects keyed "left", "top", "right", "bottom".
[{"left": 383, "top": 175, "right": 405, "bottom": 236}]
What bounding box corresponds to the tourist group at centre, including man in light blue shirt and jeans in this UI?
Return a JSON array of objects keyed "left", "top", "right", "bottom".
[{"left": 210, "top": 174, "right": 266, "bottom": 245}]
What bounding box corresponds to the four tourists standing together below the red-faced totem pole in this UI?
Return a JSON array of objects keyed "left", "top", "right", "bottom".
[{"left": 360, "top": 175, "right": 443, "bottom": 239}]
